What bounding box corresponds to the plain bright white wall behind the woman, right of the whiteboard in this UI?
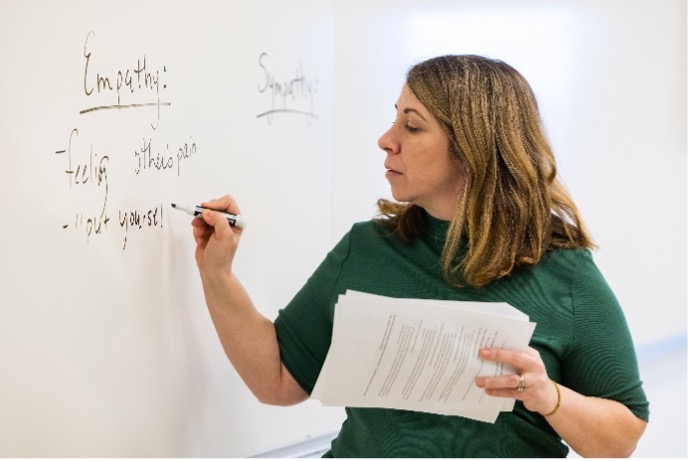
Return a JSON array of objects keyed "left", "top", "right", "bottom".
[{"left": 333, "top": 0, "right": 688, "bottom": 456}]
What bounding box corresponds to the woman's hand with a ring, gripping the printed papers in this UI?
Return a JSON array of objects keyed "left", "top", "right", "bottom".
[{"left": 476, "top": 347, "right": 558, "bottom": 414}]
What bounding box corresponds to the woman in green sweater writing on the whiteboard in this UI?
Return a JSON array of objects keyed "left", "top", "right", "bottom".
[{"left": 193, "top": 56, "right": 648, "bottom": 457}]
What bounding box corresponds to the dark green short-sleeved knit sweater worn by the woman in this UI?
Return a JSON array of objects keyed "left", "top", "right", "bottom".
[{"left": 275, "top": 216, "right": 649, "bottom": 458}]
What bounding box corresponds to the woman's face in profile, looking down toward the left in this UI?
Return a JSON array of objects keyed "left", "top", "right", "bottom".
[{"left": 379, "top": 85, "right": 464, "bottom": 220}]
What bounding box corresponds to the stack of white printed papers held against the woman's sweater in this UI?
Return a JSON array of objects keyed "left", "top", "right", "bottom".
[{"left": 311, "top": 290, "right": 535, "bottom": 422}]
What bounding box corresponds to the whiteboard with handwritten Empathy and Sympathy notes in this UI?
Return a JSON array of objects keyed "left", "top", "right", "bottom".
[{"left": 0, "top": 0, "right": 342, "bottom": 457}]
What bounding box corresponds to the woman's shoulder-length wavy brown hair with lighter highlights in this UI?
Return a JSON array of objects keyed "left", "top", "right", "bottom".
[{"left": 377, "top": 55, "right": 595, "bottom": 287}]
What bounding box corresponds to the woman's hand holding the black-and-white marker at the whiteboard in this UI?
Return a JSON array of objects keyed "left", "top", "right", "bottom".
[{"left": 192, "top": 195, "right": 242, "bottom": 274}]
